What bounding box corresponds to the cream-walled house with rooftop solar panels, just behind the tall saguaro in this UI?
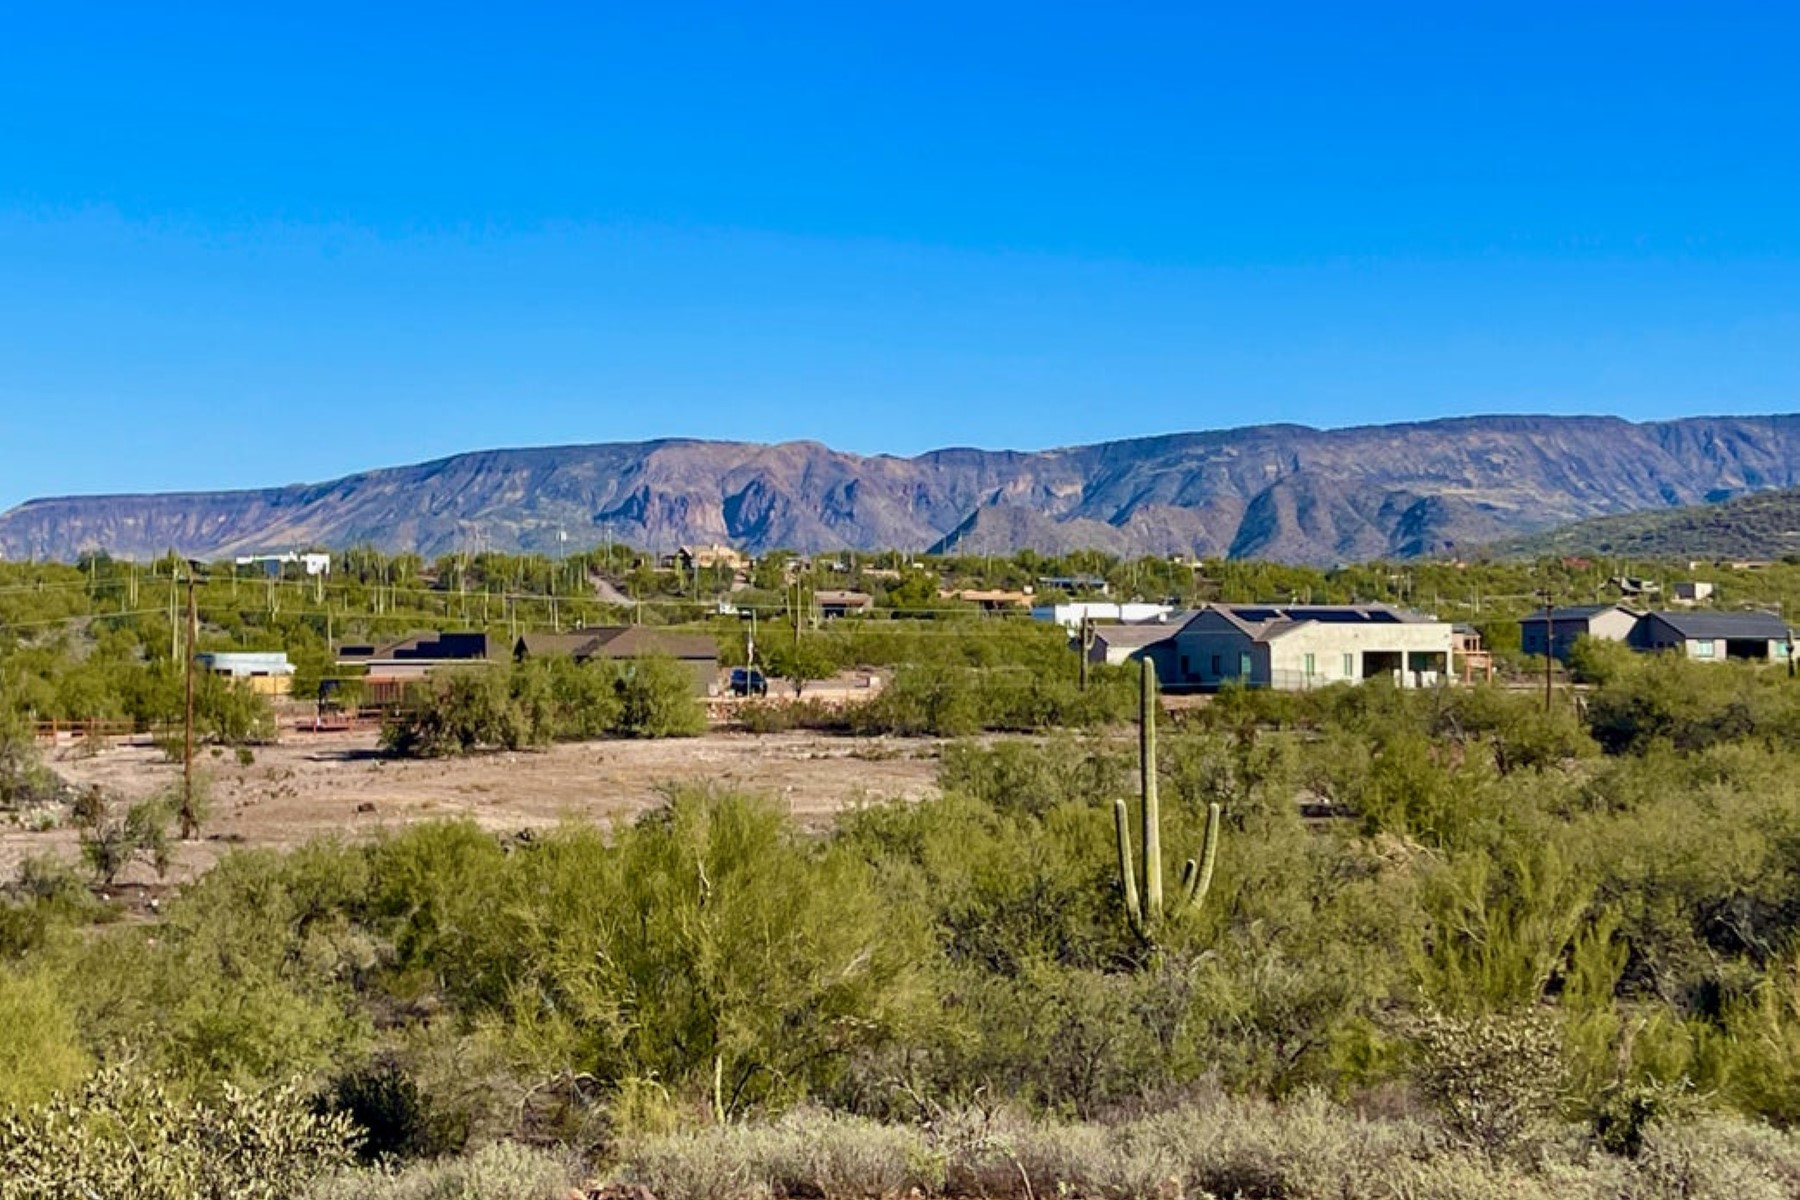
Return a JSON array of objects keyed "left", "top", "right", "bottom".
[{"left": 1159, "top": 604, "right": 1454, "bottom": 691}]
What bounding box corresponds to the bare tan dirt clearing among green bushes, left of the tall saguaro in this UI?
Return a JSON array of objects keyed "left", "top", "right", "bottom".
[{"left": 0, "top": 732, "right": 940, "bottom": 882}]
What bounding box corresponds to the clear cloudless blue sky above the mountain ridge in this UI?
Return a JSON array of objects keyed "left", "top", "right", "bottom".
[{"left": 0, "top": 2, "right": 1800, "bottom": 507}]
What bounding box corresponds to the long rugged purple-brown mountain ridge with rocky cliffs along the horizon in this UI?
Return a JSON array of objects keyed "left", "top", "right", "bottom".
[{"left": 0, "top": 416, "right": 1800, "bottom": 563}]
